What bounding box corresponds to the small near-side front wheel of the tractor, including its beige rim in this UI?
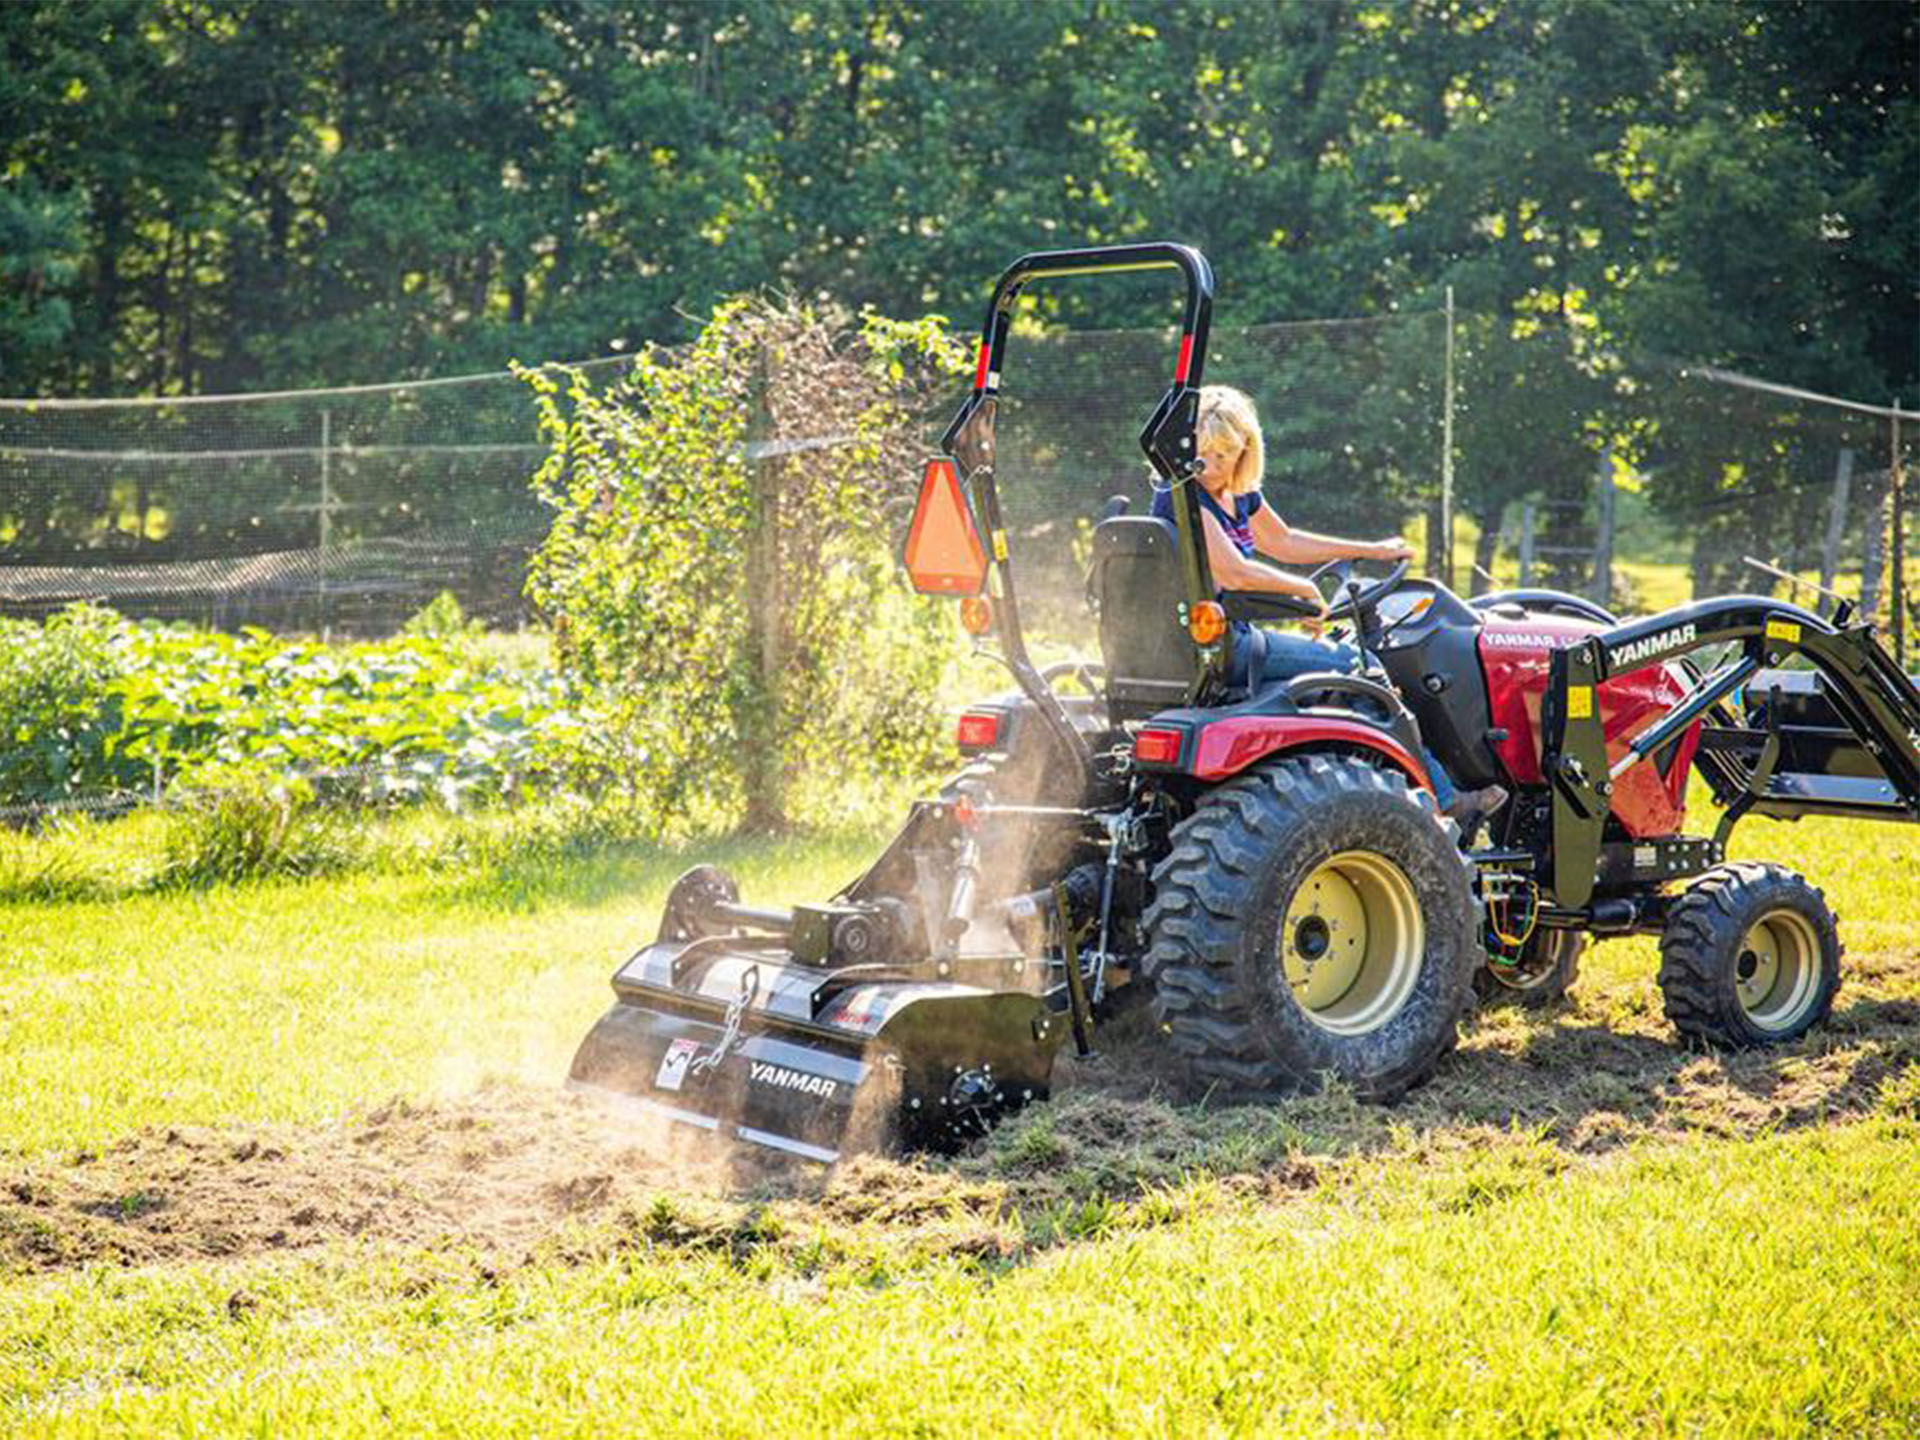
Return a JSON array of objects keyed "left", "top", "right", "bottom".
[{"left": 1661, "top": 862, "right": 1841, "bottom": 1050}]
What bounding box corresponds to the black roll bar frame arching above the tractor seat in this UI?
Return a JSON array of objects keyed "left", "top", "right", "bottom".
[{"left": 941, "top": 242, "right": 1225, "bottom": 770}]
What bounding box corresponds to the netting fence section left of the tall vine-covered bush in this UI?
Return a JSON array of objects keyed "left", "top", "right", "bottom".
[{"left": 0, "top": 357, "right": 632, "bottom": 634}]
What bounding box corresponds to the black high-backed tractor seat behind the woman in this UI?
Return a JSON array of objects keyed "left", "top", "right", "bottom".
[{"left": 1087, "top": 515, "right": 1198, "bottom": 726}]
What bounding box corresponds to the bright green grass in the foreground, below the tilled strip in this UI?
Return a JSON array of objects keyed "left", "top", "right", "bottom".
[{"left": 0, "top": 1121, "right": 1920, "bottom": 1436}]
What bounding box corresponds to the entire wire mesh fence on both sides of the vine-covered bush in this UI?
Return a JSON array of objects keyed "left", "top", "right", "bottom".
[{"left": 0, "top": 320, "right": 1914, "bottom": 647}]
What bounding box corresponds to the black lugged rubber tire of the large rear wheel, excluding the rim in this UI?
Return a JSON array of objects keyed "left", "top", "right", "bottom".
[{"left": 1144, "top": 755, "right": 1482, "bottom": 1100}]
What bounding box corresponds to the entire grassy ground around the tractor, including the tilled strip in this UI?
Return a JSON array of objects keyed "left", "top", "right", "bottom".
[{"left": 0, "top": 806, "right": 1920, "bottom": 1436}]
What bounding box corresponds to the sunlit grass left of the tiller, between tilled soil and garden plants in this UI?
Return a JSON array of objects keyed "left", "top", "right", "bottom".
[{"left": 0, "top": 822, "right": 874, "bottom": 1154}]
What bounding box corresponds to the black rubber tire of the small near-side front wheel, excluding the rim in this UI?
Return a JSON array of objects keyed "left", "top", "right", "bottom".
[{"left": 1661, "top": 860, "right": 1841, "bottom": 1050}]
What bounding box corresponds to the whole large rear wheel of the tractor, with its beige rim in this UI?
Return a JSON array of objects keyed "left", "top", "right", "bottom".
[{"left": 1144, "top": 755, "right": 1480, "bottom": 1100}]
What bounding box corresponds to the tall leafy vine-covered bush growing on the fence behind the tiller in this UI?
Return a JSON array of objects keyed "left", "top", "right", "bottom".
[{"left": 526, "top": 300, "right": 962, "bottom": 828}]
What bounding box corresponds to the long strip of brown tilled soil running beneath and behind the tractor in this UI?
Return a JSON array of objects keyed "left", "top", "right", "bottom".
[{"left": 0, "top": 956, "right": 1920, "bottom": 1273}]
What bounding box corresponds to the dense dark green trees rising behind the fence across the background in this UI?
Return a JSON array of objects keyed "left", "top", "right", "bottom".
[{"left": 0, "top": 0, "right": 1920, "bottom": 599}]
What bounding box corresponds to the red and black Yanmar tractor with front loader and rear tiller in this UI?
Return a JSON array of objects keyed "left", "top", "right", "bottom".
[{"left": 570, "top": 244, "right": 1920, "bottom": 1162}]
